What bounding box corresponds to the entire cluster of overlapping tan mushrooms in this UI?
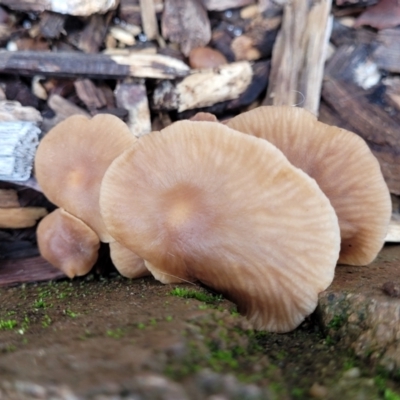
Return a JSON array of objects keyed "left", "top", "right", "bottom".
[{"left": 35, "top": 107, "right": 390, "bottom": 332}]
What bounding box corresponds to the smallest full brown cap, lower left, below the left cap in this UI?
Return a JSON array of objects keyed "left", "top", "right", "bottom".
[{"left": 36, "top": 208, "right": 100, "bottom": 278}]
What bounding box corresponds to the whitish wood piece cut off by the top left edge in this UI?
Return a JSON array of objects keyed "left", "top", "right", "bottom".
[{"left": 0, "top": 0, "right": 119, "bottom": 17}]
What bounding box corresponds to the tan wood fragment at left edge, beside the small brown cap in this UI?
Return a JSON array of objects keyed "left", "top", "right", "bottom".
[{"left": 0, "top": 207, "right": 47, "bottom": 229}]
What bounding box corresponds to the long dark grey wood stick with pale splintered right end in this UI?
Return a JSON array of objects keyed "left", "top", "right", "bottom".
[{"left": 0, "top": 51, "right": 189, "bottom": 79}]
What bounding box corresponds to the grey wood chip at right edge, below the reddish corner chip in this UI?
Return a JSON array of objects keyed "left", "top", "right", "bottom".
[{"left": 373, "top": 28, "right": 400, "bottom": 73}]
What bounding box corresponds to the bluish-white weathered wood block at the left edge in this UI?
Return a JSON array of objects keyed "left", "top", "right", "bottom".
[{"left": 0, "top": 121, "right": 40, "bottom": 181}]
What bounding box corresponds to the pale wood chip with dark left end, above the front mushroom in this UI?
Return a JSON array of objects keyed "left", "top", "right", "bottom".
[{"left": 153, "top": 61, "right": 253, "bottom": 112}]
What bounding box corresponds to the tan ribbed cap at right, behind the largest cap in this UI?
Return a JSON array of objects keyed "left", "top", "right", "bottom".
[{"left": 227, "top": 107, "right": 392, "bottom": 265}]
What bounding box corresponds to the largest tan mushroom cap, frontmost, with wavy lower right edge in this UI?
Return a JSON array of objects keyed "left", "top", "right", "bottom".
[{"left": 100, "top": 121, "right": 340, "bottom": 331}]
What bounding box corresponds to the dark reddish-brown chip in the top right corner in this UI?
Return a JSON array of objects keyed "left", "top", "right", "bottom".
[{"left": 354, "top": 0, "right": 400, "bottom": 29}]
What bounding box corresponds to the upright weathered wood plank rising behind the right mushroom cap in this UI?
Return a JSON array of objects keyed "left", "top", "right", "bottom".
[{"left": 265, "top": 0, "right": 332, "bottom": 114}]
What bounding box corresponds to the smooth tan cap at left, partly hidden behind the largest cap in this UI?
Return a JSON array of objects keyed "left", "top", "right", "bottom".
[{"left": 35, "top": 114, "right": 136, "bottom": 242}]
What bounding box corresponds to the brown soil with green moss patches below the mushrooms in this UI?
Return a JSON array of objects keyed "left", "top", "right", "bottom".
[{"left": 0, "top": 275, "right": 400, "bottom": 400}]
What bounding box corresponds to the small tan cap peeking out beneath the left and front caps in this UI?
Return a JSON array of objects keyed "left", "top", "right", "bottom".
[{"left": 110, "top": 242, "right": 150, "bottom": 278}]
